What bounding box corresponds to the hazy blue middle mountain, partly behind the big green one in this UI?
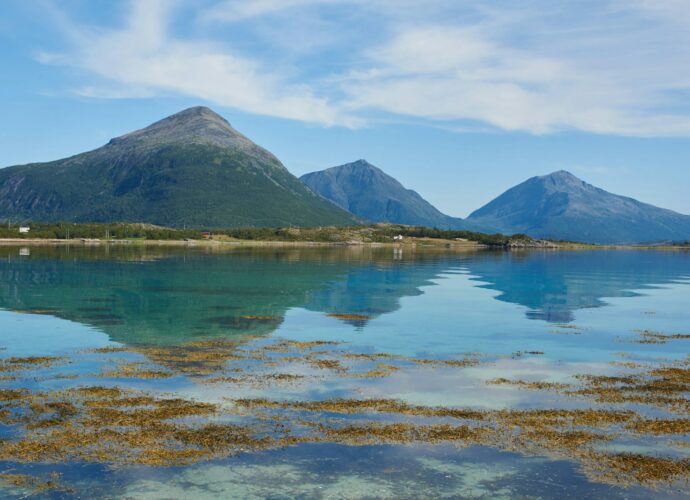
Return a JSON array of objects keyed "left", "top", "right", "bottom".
[{"left": 300, "top": 160, "right": 472, "bottom": 229}]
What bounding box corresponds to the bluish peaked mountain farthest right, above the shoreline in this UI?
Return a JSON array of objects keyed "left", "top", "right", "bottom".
[{"left": 468, "top": 170, "right": 690, "bottom": 243}]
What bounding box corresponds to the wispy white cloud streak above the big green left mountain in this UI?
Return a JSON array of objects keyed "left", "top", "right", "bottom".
[{"left": 46, "top": 0, "right": 357, "bottom": 126}]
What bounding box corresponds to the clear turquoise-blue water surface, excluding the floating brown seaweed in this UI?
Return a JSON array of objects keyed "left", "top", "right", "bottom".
[{"left": 0, "top": 247, "right": 690, "bottom": 498}]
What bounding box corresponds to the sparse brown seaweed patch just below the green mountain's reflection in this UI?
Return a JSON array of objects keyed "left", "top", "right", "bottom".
[{"left": 86, "top": 337, "right": 480, "bottom": 388}]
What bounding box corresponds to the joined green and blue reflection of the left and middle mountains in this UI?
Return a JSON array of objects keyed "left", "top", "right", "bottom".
[{"left": 0, "top": 247, "right": 462, "bottom": 344}]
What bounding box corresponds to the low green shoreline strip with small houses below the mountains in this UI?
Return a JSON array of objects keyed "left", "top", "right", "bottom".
[{"left": 0, "top": 223, "right": 690, "bottom": 250}]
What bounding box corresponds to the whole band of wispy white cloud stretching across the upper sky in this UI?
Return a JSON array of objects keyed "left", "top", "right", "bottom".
[{"left": 40, "top": 0, "right": 690, "bottom": 136}]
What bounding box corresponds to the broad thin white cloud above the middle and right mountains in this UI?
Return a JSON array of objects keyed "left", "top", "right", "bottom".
[{"left": 344, "top": 1, "right": 690, "bottom": 135}]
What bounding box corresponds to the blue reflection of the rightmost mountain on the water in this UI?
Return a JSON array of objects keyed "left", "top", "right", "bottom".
[{"left": 465, "top": 250, "right": 690, "bottom": 323}]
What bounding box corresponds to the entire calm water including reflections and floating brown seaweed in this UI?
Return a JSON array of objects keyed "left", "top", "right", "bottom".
[{"left": 0, "top": 246, "right": 690, "bottom": 498}]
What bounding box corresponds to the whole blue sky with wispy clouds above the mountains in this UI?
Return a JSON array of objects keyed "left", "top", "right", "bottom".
[{"left": 0, "top": 0, "right": 690, "bottom": 217}]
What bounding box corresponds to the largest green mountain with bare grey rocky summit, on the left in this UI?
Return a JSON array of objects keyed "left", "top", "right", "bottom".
[{"left": 0, "top": 107, "right": 359, "bottom": 228}]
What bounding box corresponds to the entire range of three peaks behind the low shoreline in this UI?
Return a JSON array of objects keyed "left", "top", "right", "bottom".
[{"left": 0, "top": 107, "right": 690, "bottom": 243}]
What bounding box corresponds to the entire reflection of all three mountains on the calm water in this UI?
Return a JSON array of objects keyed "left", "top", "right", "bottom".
[{"left": 0, "top": 246, "right": 690, "bottom": 344}]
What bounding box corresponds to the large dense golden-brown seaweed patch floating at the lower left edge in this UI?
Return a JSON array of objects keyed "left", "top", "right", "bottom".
[{"left": 0, "top": 386, "right": 268, "bottom": 465}]
